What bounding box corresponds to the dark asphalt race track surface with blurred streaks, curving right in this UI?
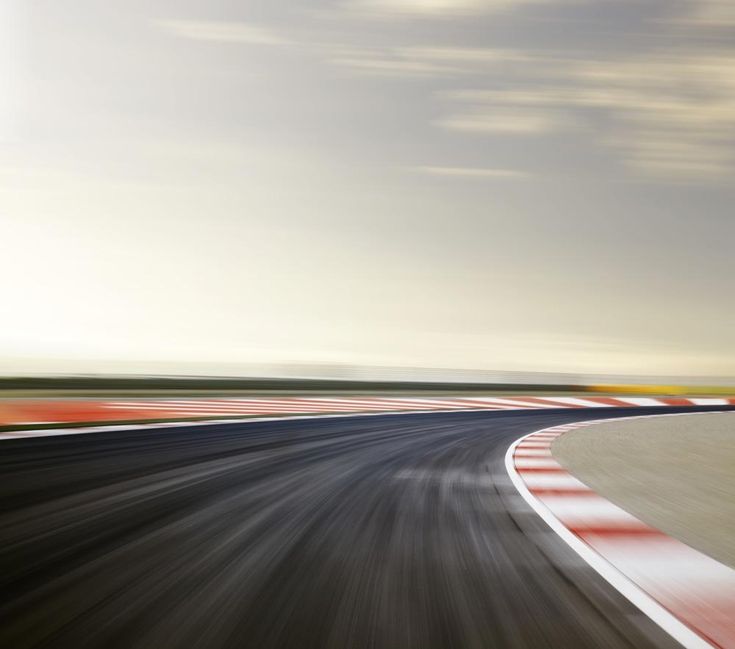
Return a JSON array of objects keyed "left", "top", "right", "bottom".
[{"left": 0, "top": 408, "right": 732, "bottom": 649}]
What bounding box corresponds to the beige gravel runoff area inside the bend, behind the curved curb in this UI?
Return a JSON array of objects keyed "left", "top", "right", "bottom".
[{"left": 552, "top": 412, "right": 735, "bottom": 568}]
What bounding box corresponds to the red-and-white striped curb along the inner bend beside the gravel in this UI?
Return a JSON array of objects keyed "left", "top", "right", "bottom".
[{"left": 505, "top": 415, "right": 735, "bottom": 649}]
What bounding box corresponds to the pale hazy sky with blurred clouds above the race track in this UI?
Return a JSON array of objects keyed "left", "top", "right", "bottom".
[{"left": 0, "top": 0, "right": 735, "bottom": 376}]
